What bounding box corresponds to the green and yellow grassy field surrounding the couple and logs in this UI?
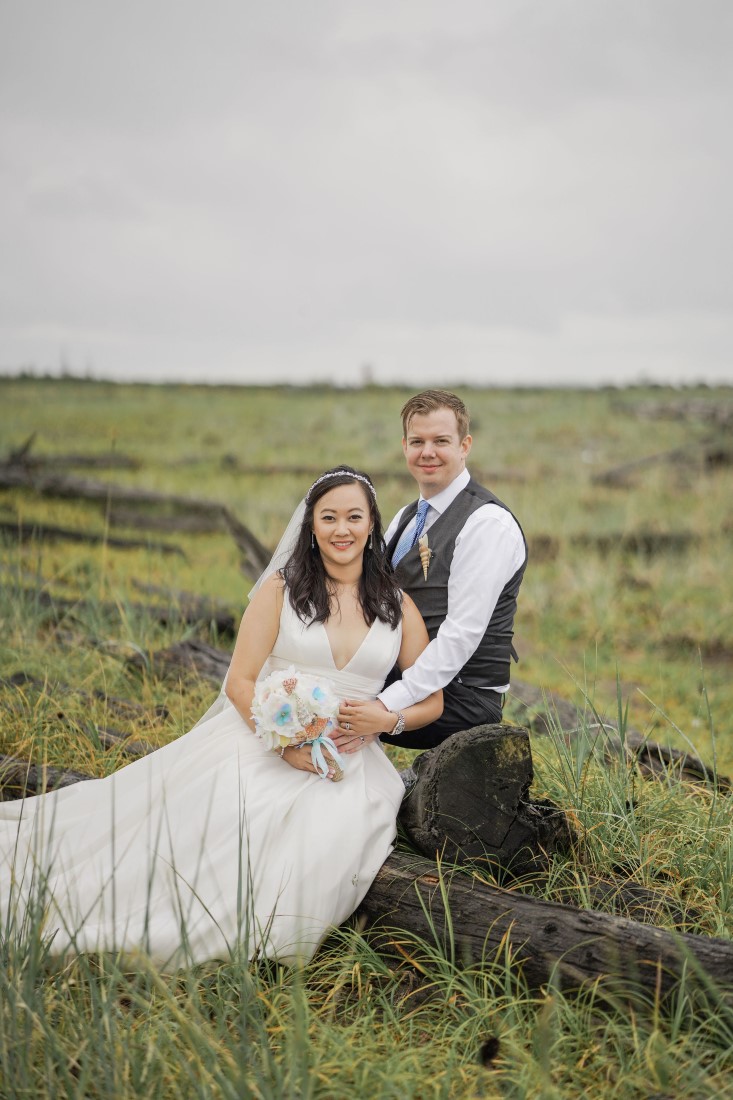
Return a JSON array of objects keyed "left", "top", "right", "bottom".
[{"left": 0, "top": 378, "right": 733, "bottom": 1098}]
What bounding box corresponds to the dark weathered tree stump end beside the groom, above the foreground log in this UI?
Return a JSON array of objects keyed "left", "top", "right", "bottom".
[{"left": 400, "top": 724, "right": 571, "bottom": 875}]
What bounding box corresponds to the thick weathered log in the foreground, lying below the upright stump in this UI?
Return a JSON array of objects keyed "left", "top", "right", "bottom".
[{"left": 360, "top": 851, "right": 733, "bottom": 997}]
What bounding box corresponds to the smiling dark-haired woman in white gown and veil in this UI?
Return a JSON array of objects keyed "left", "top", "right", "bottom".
[{"left": 0, "top": 466, "right": 442, "bottom": 967}]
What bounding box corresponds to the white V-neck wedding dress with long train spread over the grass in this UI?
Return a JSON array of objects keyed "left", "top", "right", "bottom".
[{"left": 0, "top": 598, "right": 404, "bottom": 967}]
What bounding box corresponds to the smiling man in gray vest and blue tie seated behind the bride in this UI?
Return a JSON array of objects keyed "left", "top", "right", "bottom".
[{"left": 379, "top": 389, "right": 527, "bottom": 749}]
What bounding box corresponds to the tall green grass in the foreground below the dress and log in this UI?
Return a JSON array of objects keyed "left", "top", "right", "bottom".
[{"left": 0, "top": 880, "right": 733, "bottom": 1100}]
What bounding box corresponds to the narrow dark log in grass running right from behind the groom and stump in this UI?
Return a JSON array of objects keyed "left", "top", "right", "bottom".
[{"left": 510, "top": 680, "right": 733, "bottom": 793}]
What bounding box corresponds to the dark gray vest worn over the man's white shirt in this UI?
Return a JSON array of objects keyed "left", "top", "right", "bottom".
[{"left": 387, "top": 479, "right": 527, "bottom": 688}]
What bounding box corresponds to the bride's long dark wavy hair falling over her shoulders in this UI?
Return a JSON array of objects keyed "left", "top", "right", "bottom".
[{"left": 282, "top": 466, "right": 402, "bottom": 630}]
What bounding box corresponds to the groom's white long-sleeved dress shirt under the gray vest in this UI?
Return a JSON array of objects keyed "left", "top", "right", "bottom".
[{"left": 379, "top": 470, "right": 526, "bottom": 712}]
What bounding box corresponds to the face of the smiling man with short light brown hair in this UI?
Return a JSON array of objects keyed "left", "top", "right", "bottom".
[{"left": 402, "top": 409, "right": 471, "bottom": 501}]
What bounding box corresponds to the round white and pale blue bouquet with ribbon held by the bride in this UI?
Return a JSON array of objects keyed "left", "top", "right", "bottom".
[{"left": 252, "top": 666, "right": 343, "bottom": 779}]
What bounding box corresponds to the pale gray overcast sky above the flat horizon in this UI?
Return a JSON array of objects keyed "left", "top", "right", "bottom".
[{"left": 0, "top": 0, "right": 733, "bottom": 385}]
